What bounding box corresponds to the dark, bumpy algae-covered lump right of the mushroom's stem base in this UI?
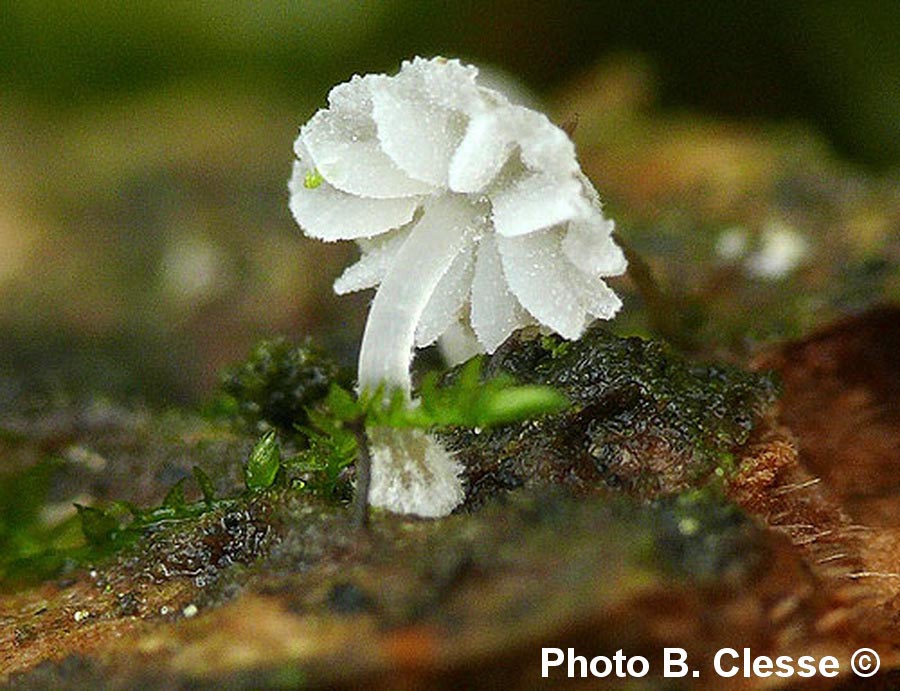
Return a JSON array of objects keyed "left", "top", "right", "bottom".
[{"left": 449, "top": 327, "right": 777, "bottom": 506}]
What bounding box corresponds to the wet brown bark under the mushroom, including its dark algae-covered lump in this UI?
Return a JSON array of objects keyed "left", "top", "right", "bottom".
[{"left": 0, "top": 308, "right": 900, "bottom": 688}]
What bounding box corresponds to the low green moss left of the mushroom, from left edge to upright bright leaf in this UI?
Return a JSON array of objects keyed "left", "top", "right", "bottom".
[{"left": 0, "top": 414, "right": 281, "bottom": 588}]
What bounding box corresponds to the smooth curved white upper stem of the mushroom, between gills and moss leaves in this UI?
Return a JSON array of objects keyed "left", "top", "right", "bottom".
[{"left": 359, "top": 196, "right": 474, "bottom": 398}]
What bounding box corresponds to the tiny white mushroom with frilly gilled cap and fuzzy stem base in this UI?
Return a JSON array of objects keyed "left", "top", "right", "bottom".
[{"left": 289, "top": 58, "right": 626, "bottom": 515}]
